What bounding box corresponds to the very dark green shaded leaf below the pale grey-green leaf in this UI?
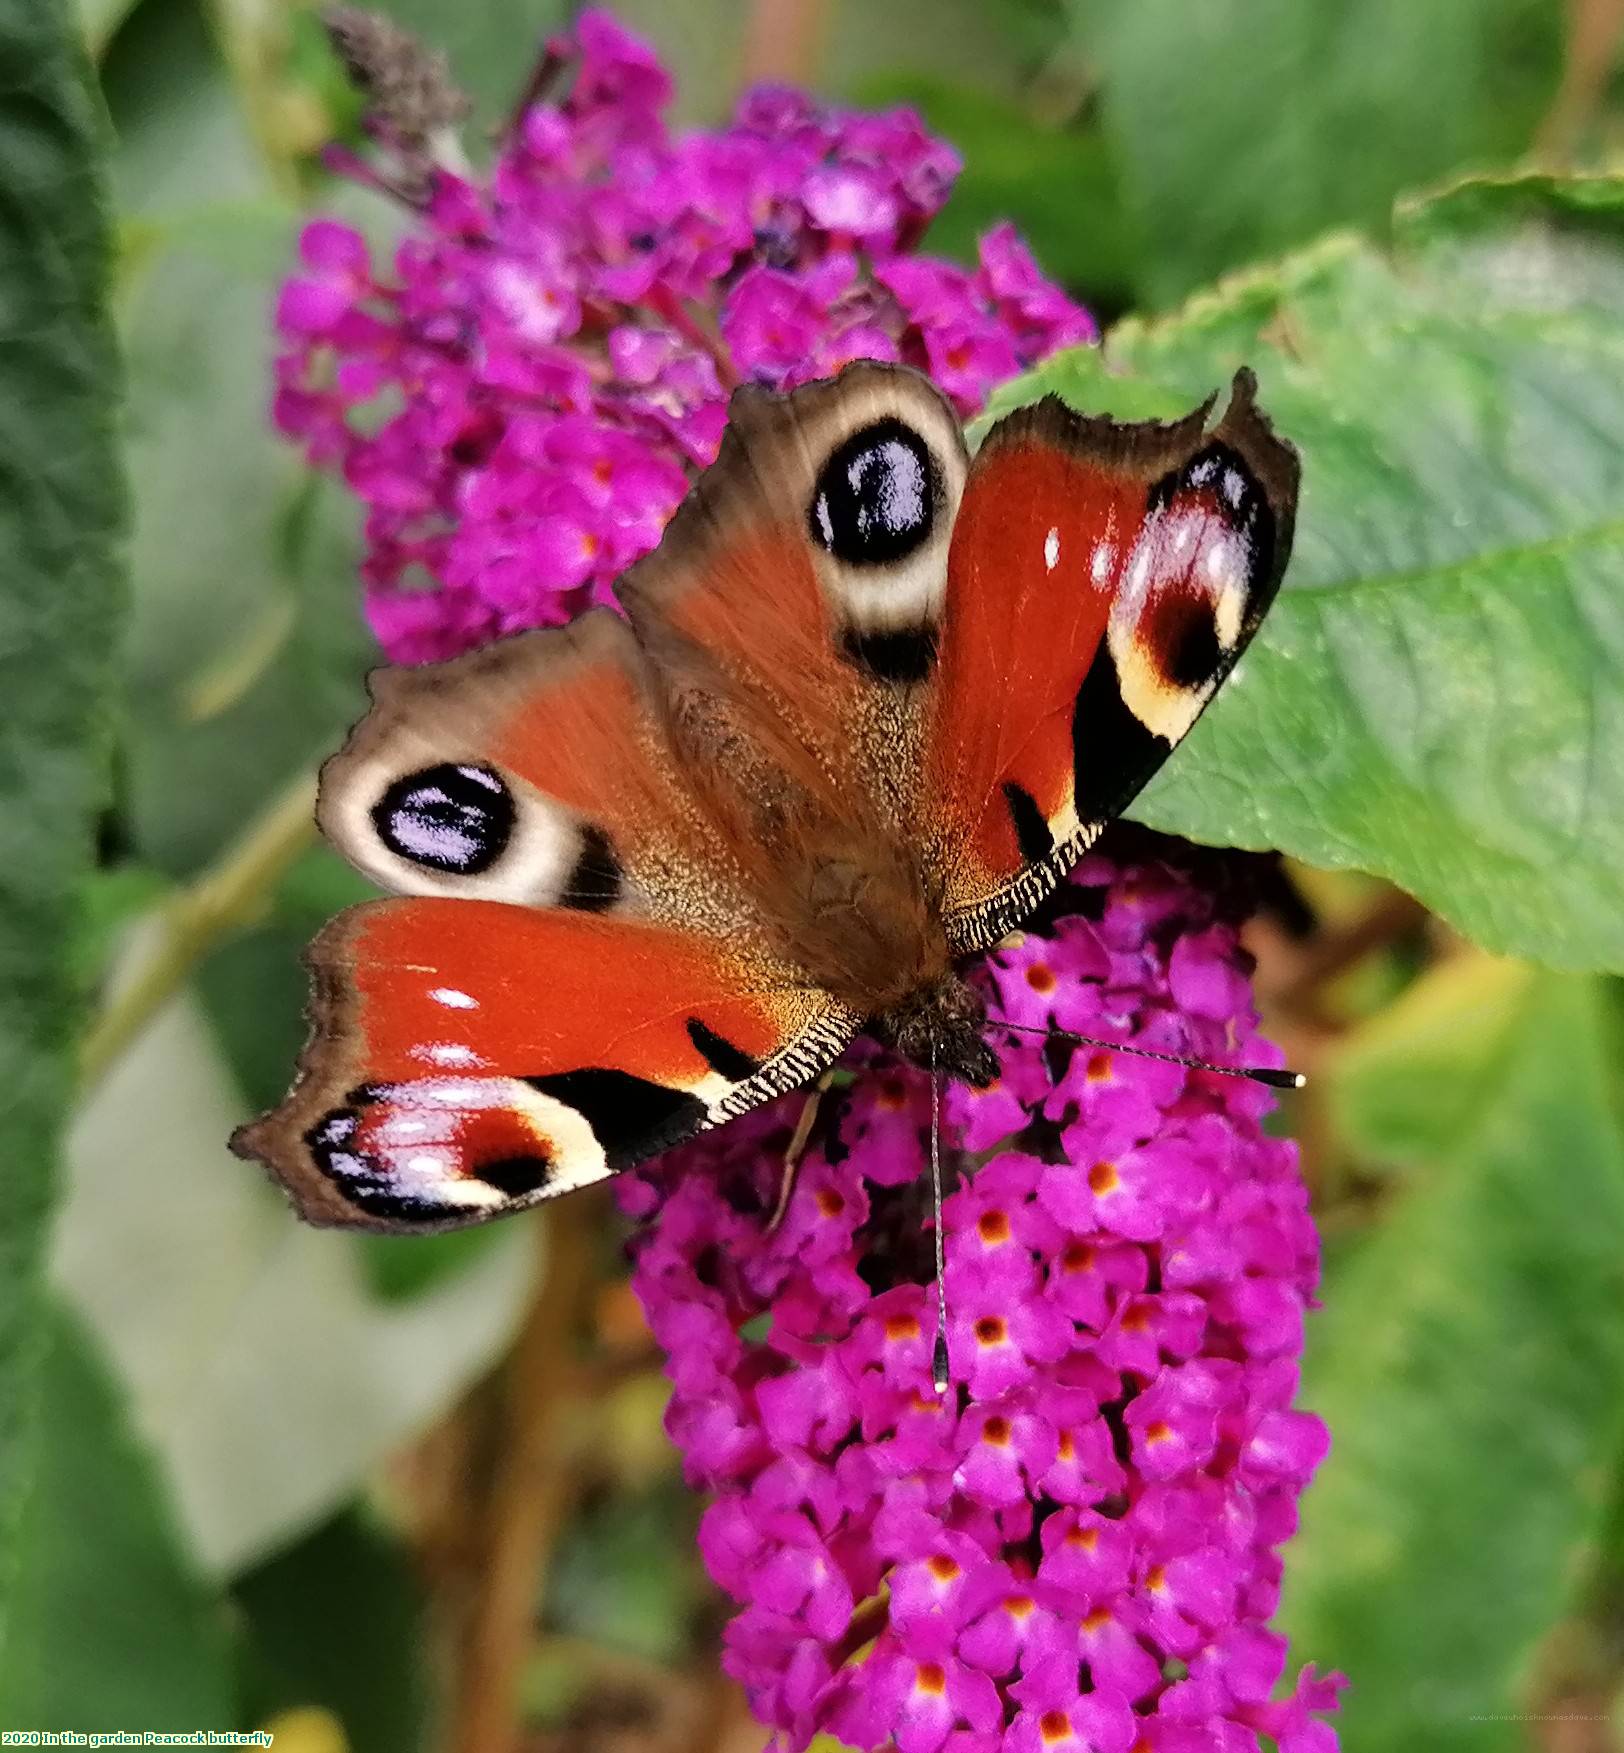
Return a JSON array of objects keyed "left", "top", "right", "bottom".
[{"left": 231, "top": 1506, "right": 433, "bottom": 1753}]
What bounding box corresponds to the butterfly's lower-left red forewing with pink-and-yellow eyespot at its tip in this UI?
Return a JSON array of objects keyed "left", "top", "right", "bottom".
[{"left": 231, "top": 896, "right": 858, "bottom": 1232}]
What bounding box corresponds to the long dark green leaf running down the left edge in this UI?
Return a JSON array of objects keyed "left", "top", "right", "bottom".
[{"left": 0, "top": 5, "right": 125, "bottom": 1654}]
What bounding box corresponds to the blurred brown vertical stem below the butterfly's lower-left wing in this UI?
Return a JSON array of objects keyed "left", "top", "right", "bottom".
[{"left": 451, "top": 1194, "right": 600, "bottom": 1753}]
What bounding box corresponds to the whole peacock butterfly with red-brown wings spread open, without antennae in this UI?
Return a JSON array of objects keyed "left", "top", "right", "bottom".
[{"left": 233, "top": 365, "right": 1298, "bottom": 1231}]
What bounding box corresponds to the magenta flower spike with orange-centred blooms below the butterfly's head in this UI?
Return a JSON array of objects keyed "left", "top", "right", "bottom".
[{"left": 623, "top": 844, "right": 1340, "bottom": 1753}]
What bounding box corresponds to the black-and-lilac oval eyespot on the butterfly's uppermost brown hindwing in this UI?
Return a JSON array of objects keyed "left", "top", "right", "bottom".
[{"left": 808, "top": 419, "right": 942, "bottom": 566}]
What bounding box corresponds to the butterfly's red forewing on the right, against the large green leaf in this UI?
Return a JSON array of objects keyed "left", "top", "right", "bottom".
[{"left": 922, "top": 372, "right": 1298, "bottom": 952}]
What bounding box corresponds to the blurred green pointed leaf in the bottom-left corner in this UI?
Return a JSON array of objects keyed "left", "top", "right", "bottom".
[{"left": 0, "top": 1309, "right": 235, "bottom": 1734}]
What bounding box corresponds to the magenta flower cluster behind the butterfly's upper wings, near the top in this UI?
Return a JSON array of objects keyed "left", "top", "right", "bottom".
[{"left": 274, "top": 11, "right": 1094, "bottom": 663}]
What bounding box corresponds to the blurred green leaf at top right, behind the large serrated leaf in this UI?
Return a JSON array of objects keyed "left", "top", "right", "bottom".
[{"left": 1070, "top": 0, "right": 1563, "bottom": 303}]
